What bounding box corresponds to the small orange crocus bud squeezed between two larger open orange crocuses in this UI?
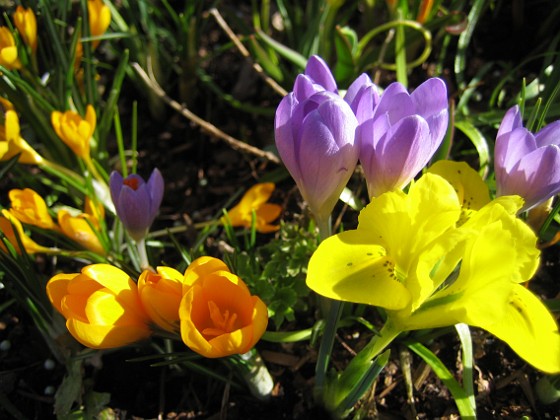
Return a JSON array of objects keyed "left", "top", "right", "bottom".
[{"left": 138, "top": 267, "right": 184, "bottom": 332}]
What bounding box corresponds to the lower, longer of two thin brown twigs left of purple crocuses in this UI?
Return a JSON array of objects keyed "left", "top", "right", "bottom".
[{"left": 132, "top": 63, "right": 280, "bottom": 163}]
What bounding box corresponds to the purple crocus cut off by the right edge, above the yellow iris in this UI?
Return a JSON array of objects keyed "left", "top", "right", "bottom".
[{"left": 494, "top": 105, "right": 560, "bottom": 211}]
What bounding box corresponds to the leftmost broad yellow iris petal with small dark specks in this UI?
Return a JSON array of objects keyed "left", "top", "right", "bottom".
[{"left": 307, "top": 230, "right": 410, "bottom": 309}]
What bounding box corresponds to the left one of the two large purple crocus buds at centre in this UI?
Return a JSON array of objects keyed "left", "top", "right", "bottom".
[{"left": 274, "top": 91, "right": 358, "bottom": 223}]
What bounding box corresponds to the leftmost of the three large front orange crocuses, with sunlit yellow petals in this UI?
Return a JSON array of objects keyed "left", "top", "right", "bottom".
[{"left": 47, "top": 264, "right": 151, "bottom": 349}]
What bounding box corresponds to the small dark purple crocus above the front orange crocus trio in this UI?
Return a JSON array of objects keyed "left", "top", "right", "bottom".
[{"left": 109, "top": 169, "right": 164, "bottom": 241}]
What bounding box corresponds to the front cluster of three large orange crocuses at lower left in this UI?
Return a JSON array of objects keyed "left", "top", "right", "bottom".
[{"left": 47, "top": 257, "right": 268, "bottom": 358}]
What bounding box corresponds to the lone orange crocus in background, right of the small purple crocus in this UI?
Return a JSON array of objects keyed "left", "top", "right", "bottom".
[{"left": 222, "top": 182, "right": 282, "bottom": 233}]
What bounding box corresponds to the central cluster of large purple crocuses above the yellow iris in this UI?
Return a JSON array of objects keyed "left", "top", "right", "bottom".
[{"left": 275, "top": 56, "right": 448, "bottom": 230}]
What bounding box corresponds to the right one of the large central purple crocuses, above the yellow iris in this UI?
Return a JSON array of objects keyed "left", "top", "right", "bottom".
[{"left": 356, "top": 78, "right": 448, "bottom": 197}]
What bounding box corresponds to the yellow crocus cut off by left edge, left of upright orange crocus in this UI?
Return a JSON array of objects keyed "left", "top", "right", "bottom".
[{"left": 0, "top": 109, "right": 44, "bottom": 165}]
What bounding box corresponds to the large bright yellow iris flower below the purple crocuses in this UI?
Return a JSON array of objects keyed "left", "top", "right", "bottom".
[{"left": 307, "top": 168, "right": 560, "bottom": 373}]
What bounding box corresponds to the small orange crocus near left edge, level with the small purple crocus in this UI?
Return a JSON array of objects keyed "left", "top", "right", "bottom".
[{"left": 8, "top": 188, "right": 58, "bottom": 230}]
